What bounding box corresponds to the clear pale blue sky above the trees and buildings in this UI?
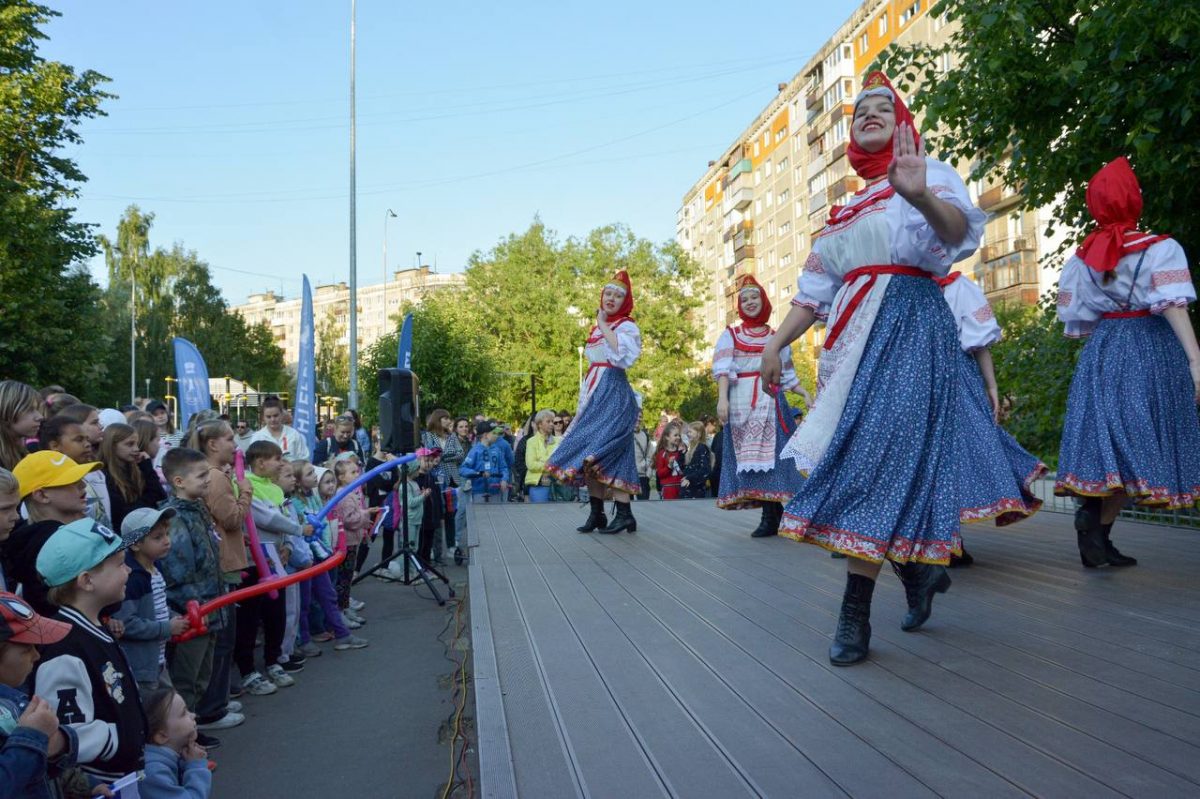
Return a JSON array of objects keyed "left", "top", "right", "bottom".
[{"left": 42, "top": 0, "right": 857, "bottom": 305}]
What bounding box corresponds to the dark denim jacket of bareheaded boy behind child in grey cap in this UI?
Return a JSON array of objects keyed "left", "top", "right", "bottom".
[{"left": 158, "top": 497, "right": 224, "bottom": 631}]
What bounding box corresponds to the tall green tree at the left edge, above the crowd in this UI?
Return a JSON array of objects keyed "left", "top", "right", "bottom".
[{"left": 0, "top": 0, "right": 110, "bottom": 384}]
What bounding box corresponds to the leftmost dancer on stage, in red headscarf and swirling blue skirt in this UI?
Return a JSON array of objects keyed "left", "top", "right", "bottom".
[{"left": 546, "top": 270, "right": 642, "bottom": 533}]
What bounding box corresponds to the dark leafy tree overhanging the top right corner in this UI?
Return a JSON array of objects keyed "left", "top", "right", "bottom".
[{"left": 881, "top": 0, "right": 1200, "bottom": 261}]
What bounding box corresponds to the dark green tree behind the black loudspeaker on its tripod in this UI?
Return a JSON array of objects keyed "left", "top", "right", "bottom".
[{"left": 359, "top": 290, "right": 498, "bottom": 429}]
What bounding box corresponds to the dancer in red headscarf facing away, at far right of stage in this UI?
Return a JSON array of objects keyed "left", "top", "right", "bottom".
[{"left": 1055, "top": 158, "right": 1200, "bottom": 567}]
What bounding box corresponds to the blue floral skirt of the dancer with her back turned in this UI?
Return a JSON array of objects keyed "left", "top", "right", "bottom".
[{"left": 1054, "top": 317, "right": 1200, "bottom": 510}]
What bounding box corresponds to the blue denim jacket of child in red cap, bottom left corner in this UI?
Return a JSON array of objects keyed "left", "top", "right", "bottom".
[{"left": 0, "top": 685, "right": 79, "bottom": 799}]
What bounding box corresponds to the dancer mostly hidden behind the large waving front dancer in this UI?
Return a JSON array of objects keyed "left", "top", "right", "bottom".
[{"left": 937, "top": 272, "right": 1046, "bottom": 566}]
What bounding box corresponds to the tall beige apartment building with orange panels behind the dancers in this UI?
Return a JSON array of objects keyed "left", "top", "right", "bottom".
[{"left": 676, "top": 0, "right": 1057, "bottom": 367}]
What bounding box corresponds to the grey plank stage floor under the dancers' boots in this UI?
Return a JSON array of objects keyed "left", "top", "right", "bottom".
[{"left": 470, "top": 500, "right": 1200, "bottom": 799}]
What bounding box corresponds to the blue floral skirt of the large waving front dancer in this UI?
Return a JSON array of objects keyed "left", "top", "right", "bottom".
[{"left": 779, "top": 275, "right": 962, "bottom": 564}]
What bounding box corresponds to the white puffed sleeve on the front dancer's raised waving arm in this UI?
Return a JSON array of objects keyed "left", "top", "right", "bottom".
[{"left": 888, "top": 158, "right": 988, "bottom": 268}]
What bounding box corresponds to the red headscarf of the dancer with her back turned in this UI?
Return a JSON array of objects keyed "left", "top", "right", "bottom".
[{"left": 1076, "top": 156, "right": 1168, "bottom": 272}]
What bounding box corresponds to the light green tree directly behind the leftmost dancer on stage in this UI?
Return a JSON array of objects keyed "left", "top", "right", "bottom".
[{"left": 467, "top": 220, "right": 704, "bottom": 420}]
